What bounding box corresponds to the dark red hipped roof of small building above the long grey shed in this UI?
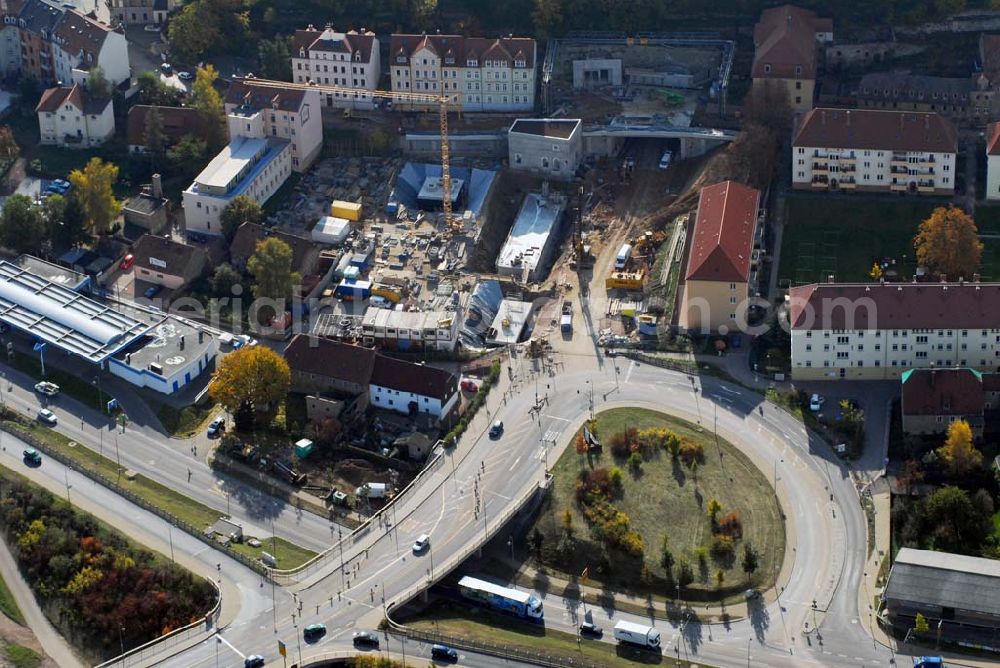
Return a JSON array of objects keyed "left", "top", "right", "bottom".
[{"left": 902, "top": 369, "right": 983, "bottom": 415}]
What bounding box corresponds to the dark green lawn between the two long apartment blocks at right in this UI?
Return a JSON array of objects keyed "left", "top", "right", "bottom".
[{"left": 778, "top": 196, "right": 940, "bottom": 285}]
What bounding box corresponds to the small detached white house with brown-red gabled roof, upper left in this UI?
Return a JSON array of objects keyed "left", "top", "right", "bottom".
[{"left": 35, "top": 84, "right": 115, "bottom": 148}]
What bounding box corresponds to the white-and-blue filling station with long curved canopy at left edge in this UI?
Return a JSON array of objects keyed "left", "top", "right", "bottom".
[{"left": 0, "top": 261, "right": 217, "bottom": 394}]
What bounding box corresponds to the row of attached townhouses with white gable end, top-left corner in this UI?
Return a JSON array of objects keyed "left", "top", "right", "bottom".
[{"left": 16, "top": 0, "right": 130, "bottom": 86}]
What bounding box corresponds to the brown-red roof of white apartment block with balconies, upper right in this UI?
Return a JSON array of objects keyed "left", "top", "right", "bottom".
[{"left": 792, "top": 108, "right": 958, "bottom": 153}]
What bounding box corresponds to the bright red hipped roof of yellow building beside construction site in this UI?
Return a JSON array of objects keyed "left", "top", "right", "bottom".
[{"left": 686, "top": 181, "right": 760, "bottom": 283}]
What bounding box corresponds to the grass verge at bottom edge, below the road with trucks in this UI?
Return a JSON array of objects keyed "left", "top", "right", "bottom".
[{"left": 400, "top": 602, "right": 692, "bottom": 668}]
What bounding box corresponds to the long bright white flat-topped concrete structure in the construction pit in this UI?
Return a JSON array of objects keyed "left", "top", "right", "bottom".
[{"left": 497, "top": 193, "right": 563, "bottom": 283}]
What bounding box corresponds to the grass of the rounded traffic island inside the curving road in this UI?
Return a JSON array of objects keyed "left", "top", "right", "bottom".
[{"left": 527, "top": 408, "right": 785, "bottom": 600}]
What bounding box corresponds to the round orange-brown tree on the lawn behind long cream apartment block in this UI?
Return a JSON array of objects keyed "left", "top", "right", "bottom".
[{"left": 913, "top": 205, "right": 983, "bottom": 280}]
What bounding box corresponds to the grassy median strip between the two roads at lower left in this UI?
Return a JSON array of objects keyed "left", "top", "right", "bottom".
[{"left": 1, "top": 412, "right": 316, "bottom": 568}]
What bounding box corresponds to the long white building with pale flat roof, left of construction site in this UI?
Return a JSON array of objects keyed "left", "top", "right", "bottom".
[{"left": 182, "top": 134, "right": 292, "bottom": 236}]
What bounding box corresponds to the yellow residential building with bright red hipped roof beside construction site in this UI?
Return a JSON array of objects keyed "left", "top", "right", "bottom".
[{"left": 678, "top": 181, "right": 763, "bottom": 333}]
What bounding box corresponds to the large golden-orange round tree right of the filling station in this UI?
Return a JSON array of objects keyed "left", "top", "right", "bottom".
[{"left": 208, "top": 346, "right": 291, "bottom": 428}]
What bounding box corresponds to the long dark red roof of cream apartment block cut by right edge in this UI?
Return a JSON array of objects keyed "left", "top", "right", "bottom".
[{"left": 789, "top": 282, "right": 1000, "bottom": 330}]
